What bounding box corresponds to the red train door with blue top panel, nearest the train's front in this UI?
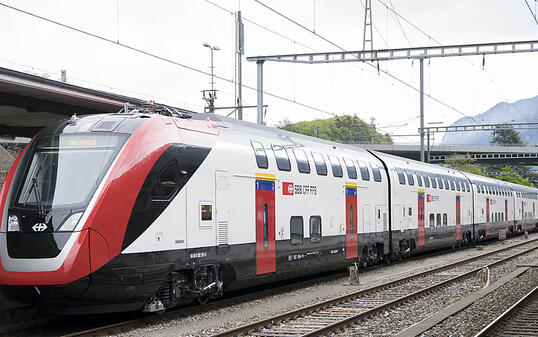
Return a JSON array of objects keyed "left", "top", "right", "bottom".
[{"left": 256, "top": 178, "right": 276, "bottom": 275}]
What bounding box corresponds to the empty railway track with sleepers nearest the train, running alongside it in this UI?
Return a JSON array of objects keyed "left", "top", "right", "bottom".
[{"left": 213, "top": 240, "right": 538, "bottom": 337}]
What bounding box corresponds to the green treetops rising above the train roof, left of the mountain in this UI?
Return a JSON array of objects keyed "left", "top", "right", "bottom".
[{"left": 277, "top": 115, "right": 393, "bottom": 144}]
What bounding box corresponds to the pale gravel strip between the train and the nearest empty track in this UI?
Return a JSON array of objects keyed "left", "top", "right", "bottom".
[{"left": 110, "top": 234, "right": 538, "bottom": 337}]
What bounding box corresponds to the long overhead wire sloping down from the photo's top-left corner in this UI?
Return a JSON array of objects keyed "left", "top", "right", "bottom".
[{"left": 0, "top": 2, "right": 336, "bottom": 116}]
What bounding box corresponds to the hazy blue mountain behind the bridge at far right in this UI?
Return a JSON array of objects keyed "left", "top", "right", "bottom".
[{"left": 441, "top": 96, "right": 538, "bottom": 146}]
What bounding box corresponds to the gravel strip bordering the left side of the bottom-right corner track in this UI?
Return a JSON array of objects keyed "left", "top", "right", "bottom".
[{"left": 420, "top": 262, "right": 538, "bottom": 337}]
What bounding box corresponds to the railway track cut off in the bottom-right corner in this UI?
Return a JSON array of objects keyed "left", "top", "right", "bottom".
[{"left": 475, "top": 286, "right": 538, "bottom": 337}]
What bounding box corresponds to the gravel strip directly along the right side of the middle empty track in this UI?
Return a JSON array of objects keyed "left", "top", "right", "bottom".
[{"left": 331, "top": 243, "right": 538, "bottom": 336}]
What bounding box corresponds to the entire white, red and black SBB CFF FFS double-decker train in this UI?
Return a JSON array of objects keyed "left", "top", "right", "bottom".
[{"left": 0, "top": 111, "right": 538, "bottom": 314}]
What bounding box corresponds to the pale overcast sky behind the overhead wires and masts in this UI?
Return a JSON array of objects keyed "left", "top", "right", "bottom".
[{"left": 0, "top": 0, "right": 538, "bottom": 142}]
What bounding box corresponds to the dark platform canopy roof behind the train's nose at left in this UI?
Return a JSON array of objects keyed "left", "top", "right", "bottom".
[{"left": 0, "top": 67, "right": 144, "bottom": 137}]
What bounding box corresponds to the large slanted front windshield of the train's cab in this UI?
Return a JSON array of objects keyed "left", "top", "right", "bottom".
[{"left": 17, "top": 133, "right": 128, "bottom": 208}]
